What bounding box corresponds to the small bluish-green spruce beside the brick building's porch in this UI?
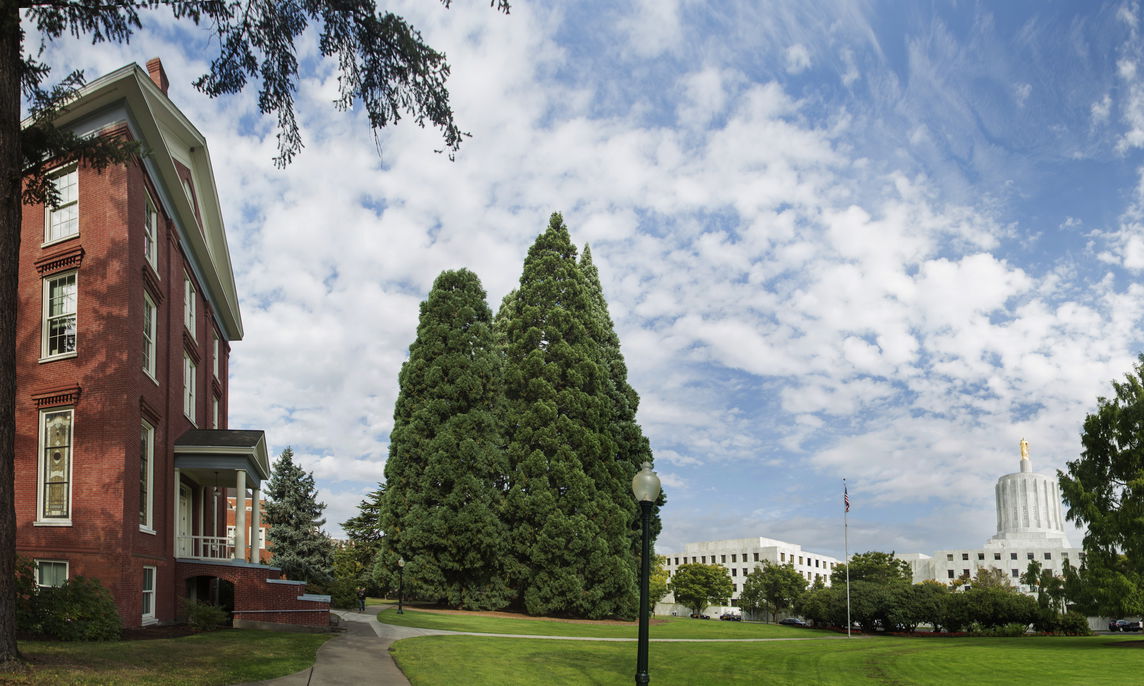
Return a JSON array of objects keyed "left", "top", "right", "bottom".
[{"left": 267, "top": 448, "right": 333, "bottom": 587}]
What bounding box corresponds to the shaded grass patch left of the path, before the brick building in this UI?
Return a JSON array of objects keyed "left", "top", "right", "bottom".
[{"left": 0, "top": 629, "right": 332, "bottom": 686}]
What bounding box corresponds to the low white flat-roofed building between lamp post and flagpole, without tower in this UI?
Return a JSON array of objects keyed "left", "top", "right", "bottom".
[{"left": 654, "top": 537, "right": 839, "bottom": 616}]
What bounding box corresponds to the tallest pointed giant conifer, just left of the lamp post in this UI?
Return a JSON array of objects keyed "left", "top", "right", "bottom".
[{"left": 498, "top": 214, "right": 637, "bottom": 617}]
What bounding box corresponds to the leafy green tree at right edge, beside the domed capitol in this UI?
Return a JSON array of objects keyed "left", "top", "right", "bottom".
[{"left": 1057, "top": 354, "right": 1144, "bottom": 616}]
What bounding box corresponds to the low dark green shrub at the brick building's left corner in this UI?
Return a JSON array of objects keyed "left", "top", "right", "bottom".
[{"left": 30, "top": 576, "right": 122, "bottom": 640}]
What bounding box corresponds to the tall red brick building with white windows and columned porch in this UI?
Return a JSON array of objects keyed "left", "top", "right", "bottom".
[{"left": 15, "top": 59, "right": 328, "bottom": 627}]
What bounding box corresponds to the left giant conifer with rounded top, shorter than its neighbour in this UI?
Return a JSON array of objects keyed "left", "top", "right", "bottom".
[{"left": 380, "top": 270, "right": 510, "bottom": 609}]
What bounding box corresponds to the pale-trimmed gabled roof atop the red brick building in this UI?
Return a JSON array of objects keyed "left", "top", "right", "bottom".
[{"left": 24, "top": 64, "right": 243, "bottom": 341}]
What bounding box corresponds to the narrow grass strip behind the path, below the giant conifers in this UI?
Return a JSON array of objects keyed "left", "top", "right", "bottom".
[{"left": 378, "top": 609, "right": 836, "bottom": 638}]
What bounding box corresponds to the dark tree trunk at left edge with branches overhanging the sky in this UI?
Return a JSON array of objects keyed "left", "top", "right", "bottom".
[{"left": 0, "top": 0, "right": 509, "bottom": 665}]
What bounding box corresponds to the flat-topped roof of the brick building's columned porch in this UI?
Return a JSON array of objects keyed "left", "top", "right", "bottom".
[{"left": 175, "top": 429, "right": 270, "bottom": 488}]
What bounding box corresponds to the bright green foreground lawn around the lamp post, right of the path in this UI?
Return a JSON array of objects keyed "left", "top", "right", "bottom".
[{"left": 392, "top": 636, "right": 1144, "bottom": 686}]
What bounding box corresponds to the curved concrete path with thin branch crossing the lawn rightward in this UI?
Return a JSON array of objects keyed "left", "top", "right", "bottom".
[{"left": 238, "top": 605, "right": 860, "bottom": 686}]
